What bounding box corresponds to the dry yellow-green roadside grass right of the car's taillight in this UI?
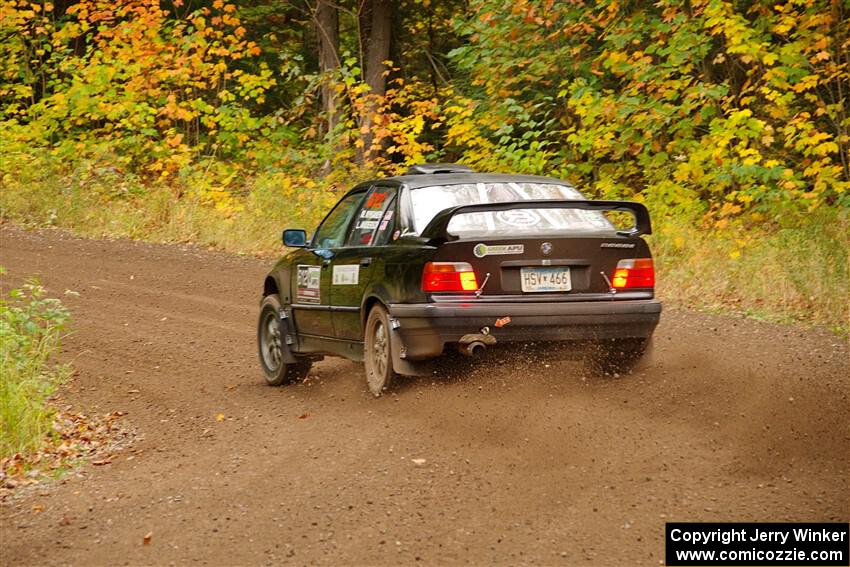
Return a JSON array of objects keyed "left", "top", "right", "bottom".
[{"left": 651, "top": 211, "right": 850, "bottom": 336}]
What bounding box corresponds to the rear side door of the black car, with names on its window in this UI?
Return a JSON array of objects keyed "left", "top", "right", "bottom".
[{"left": 330, "top": 185, "right": 396, "bottom": 341}]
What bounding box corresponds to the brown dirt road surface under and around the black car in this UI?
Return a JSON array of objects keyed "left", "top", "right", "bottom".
[{"left": 0, "top": 226, "right": 850, "bottom": 565}]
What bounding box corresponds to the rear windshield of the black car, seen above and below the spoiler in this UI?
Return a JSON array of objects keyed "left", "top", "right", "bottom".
[{"left": 410, "top": 183, "right": 613, "bottom": 236}]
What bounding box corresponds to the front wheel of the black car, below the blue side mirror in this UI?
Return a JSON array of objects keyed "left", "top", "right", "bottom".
[{"left": 257, "top": 295, "right": 311, "bottom": 386}]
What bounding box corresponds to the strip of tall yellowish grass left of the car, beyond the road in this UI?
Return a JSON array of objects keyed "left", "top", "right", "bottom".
[{"left": 0, "top": 162, "right": 340, "bottom": 253}]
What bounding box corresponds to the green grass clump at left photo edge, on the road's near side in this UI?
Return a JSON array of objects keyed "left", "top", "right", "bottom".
[{"left": 0, "top": 282, "right": 70, "bottom": 457}]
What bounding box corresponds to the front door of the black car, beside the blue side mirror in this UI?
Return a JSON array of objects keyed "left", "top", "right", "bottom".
[{"left": 290, "top": 190, "right": 366, "bottom": 337}]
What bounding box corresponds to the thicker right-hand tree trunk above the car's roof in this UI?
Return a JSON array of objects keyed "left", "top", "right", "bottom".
[{"left": 359, "top": 0, "right": 393, "bottom": 160}]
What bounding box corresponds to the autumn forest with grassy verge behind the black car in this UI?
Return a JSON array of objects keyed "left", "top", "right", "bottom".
[{"left": 0, "top": 0, "right": 850, "bottom": 332}]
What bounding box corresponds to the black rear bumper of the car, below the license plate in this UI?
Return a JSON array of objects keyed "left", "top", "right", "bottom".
[{"left": 389, "top": 299, "right": 661, "bottom": 360}]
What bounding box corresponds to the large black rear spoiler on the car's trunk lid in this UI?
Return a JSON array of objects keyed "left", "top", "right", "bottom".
[{"left": 420, "top": 199, "right": 652, "bottom": 240}]
